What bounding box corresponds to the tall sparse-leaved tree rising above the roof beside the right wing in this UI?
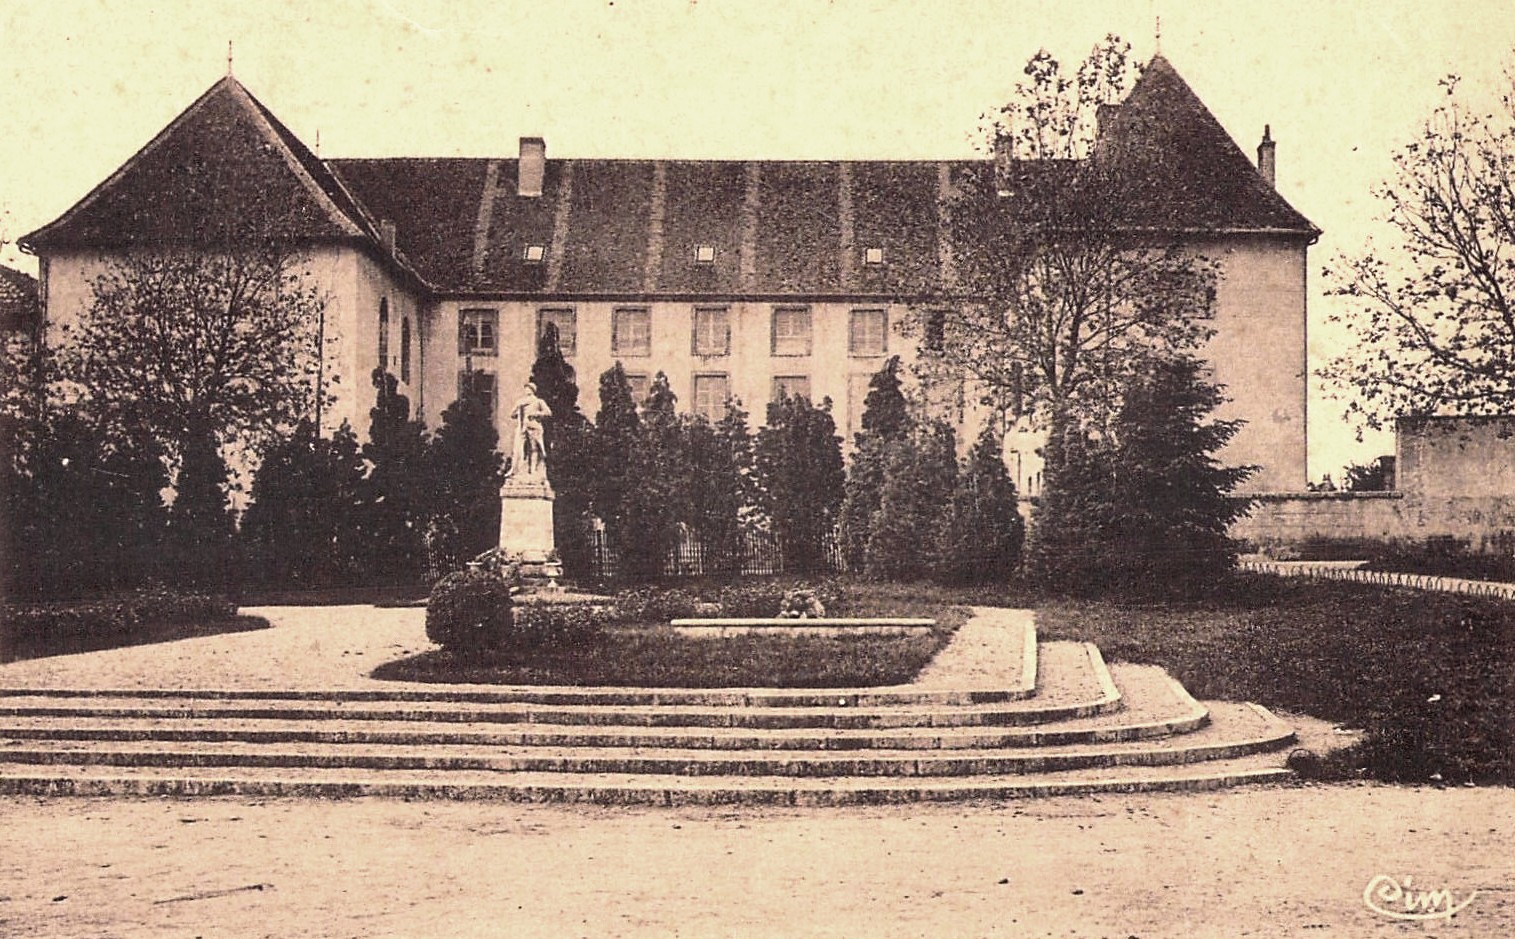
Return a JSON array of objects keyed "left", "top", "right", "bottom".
[{"left": 906, "top": 36, "right": 1215, "bottom": 426}]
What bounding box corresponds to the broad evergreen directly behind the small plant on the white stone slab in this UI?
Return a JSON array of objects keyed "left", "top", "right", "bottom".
[{"left": 753, "top": 395, "right": 845, "bottom": 571}]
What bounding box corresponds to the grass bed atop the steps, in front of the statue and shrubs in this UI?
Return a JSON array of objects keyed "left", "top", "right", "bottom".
[{"left": 373, "top": 585, "right": 968, "bottom": 688}]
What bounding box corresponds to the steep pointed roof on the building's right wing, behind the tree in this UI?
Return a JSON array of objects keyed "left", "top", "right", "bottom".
[{"left": 1100, "top": 56, "right": 1320, "bottom": 236}]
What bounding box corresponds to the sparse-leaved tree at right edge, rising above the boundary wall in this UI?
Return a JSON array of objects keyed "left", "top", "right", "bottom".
[{"left": 1323, "top": 64, "right": 1515, "bottom": 429}]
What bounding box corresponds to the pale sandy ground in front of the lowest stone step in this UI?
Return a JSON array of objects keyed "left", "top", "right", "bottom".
[{"left": 0, "top": 785, "right": 1515, "bottom": 939}]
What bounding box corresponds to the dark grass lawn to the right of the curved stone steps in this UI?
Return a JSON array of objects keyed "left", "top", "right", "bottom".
[{"left": 1038, "top": 576, "right": 1515, "bottom": 785}]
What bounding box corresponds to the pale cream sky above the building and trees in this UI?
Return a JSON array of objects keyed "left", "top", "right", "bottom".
[{"left": 0, "top": 0, "right": 1515, "bottom": 479}]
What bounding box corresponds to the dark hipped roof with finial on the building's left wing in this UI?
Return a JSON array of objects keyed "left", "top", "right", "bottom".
[{"left": 21, "top": 76, "right": 376, "bottom": 250}]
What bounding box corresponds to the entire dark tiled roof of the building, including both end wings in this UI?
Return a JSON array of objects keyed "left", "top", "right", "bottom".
[{"left": 23, "top": 56, "right": 1318, "bottom": 297}]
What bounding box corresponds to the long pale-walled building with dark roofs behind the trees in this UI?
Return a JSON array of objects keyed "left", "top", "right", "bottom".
[{"left": 21, "top": 56, "right": 1318, "bottom": 491}]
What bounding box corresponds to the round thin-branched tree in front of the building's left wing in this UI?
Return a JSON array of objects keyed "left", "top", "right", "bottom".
[{"left": 58, "top": 243, "right": 324, "bottom": 462}]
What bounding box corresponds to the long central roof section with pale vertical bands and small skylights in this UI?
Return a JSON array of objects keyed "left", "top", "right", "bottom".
[{"left": 330, "top": 159, "right": 965, "bottom": 297}]
